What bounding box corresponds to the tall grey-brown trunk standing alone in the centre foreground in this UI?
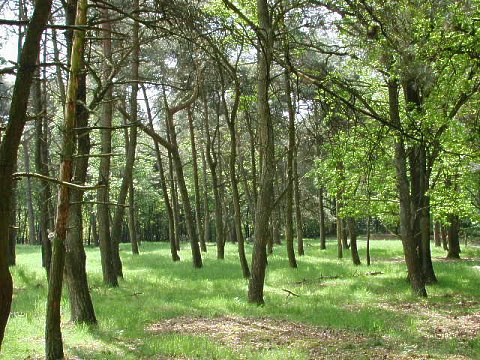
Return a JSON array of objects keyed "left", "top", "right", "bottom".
[{"left": 248, "top": 0, "right": 275, "bottom": 304}]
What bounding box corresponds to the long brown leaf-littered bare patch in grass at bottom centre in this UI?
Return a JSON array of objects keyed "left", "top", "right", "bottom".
[{"left": 147, "top": 316, "right": 465, "bottom": 360}]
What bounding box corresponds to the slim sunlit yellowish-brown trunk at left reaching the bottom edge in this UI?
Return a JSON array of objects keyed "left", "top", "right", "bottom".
[{"left": 45, "top": 0, "right": 87, "bottom": 360}]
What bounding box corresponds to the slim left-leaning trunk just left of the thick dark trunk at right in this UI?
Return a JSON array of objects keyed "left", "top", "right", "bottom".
[{"left": 388, "top": 80, "right": 427, "bottom": 297}]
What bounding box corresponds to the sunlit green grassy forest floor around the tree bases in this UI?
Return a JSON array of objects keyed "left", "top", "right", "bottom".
[{"left": 0, "top": 241, "right": 480, "bottom": 359}]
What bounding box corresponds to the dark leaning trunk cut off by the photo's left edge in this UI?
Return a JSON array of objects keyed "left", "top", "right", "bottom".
[{"left": 0, "top": 0, "right": 52, "bottom": 348}]
